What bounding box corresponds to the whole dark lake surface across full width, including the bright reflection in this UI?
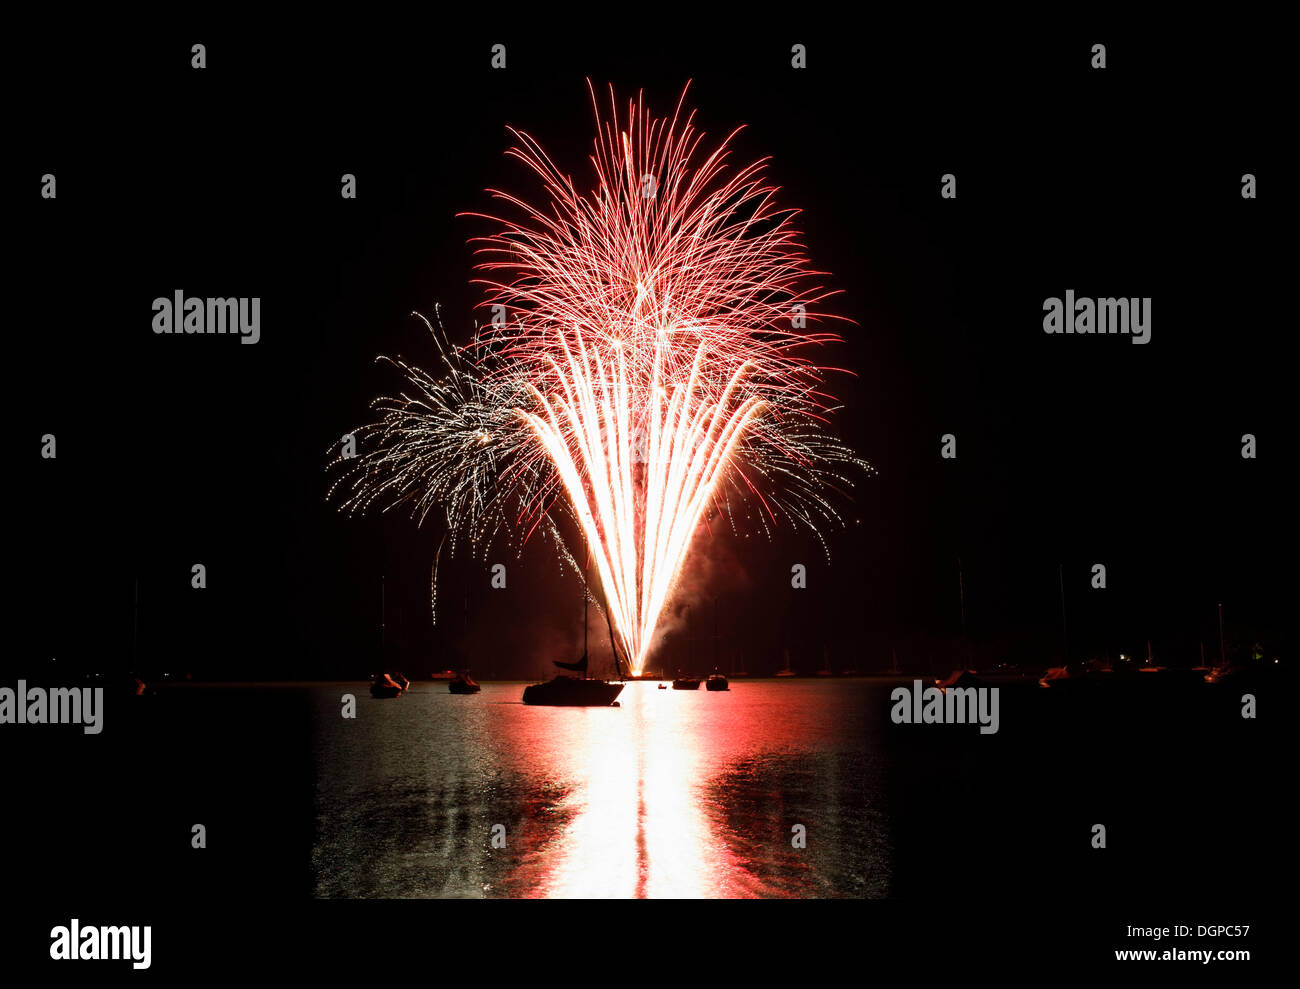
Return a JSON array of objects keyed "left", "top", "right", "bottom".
[{"left": 3, "top": 678, "right": 1268, "bottom": 904}]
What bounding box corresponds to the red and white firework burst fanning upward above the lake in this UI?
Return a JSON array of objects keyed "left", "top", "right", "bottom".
[{"left": 338, "top": 90, "right": 870, "bottom": 672}]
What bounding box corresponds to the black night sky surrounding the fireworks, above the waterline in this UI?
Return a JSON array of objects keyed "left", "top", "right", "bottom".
[{"left": 9, "top": 29, "right": 1294, "bottom": 678}]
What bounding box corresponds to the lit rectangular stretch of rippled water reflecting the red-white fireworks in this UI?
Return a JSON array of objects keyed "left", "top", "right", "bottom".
[{"left": 312, "top": 680, "right": 891, "bottom": 897}]
